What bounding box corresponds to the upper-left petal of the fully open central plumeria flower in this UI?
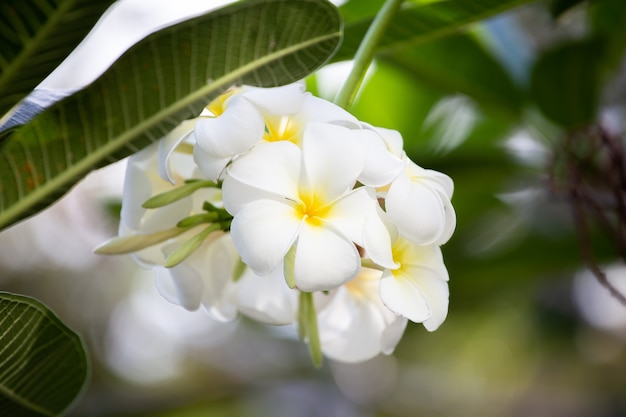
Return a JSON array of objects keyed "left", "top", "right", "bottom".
[{"left": 228, "top": 141, "right": 300, "bottom": 199}]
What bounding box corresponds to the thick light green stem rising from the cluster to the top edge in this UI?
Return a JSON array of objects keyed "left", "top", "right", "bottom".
[{"left": 335, "top": 0, "right": 403, "bottom": 109}]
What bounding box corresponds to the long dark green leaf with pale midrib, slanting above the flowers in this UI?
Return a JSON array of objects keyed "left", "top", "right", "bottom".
[{"left": 0, "top": 0, "right": 342, "bottom": 228}]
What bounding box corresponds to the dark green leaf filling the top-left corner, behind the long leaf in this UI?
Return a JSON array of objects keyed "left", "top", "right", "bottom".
[{"left": 0, "top": 0, "right": 114, "bottom": 117}]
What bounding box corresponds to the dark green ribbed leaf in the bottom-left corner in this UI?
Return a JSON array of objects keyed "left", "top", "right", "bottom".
[{"left": 0, "top": 293, "right": 89, "bottom": 417}]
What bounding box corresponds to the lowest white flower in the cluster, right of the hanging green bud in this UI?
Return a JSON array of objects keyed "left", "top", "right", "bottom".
[{"left": 316, "top": 268, "right": 407, "bottom": 362}]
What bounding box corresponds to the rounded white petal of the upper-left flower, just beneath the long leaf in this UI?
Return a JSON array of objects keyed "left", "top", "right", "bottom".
[{"left": 194, "top": 95, "right": 265, "bottom": 158}]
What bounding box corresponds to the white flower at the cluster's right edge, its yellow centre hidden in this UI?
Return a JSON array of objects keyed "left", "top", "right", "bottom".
[{"left": 385, "top": 158, "right": 456, "bottom": 245}]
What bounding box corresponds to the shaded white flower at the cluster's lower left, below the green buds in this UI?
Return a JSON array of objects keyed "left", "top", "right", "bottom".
[{"left": 155, "top": 232, "right": 239, "bottom": 321}]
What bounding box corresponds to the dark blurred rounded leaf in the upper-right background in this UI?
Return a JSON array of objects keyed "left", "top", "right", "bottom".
[{"left": 531, "top": 40, "right": 604, "bottom": 128}]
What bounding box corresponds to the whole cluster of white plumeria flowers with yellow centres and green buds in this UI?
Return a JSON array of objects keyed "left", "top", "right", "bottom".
[{"left": 96, "top": 83, "right": 456, "bottom": 362}]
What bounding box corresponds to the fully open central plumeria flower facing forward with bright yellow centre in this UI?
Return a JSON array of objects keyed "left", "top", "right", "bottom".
[{"left": 222, "top": 123, "right": 380, "bottom": 291}]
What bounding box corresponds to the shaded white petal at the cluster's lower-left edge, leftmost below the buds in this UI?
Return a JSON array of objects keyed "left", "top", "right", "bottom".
[{"left": 154, "top": 264, "right": 203, "bottom": 311}]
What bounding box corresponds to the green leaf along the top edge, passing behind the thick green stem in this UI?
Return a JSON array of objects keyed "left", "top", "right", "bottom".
[{"left": 333, "top": 0, "right": 533, "bottom": 61}]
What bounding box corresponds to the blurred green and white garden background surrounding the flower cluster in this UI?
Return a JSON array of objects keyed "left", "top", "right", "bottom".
[{"left": 0, "top": 0, "right": 626, "bottom": 417}]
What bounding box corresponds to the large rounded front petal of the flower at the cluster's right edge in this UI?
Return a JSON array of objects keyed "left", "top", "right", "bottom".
[{"left": 385, "top": 174, "right": 447, "bottom": 245}]
